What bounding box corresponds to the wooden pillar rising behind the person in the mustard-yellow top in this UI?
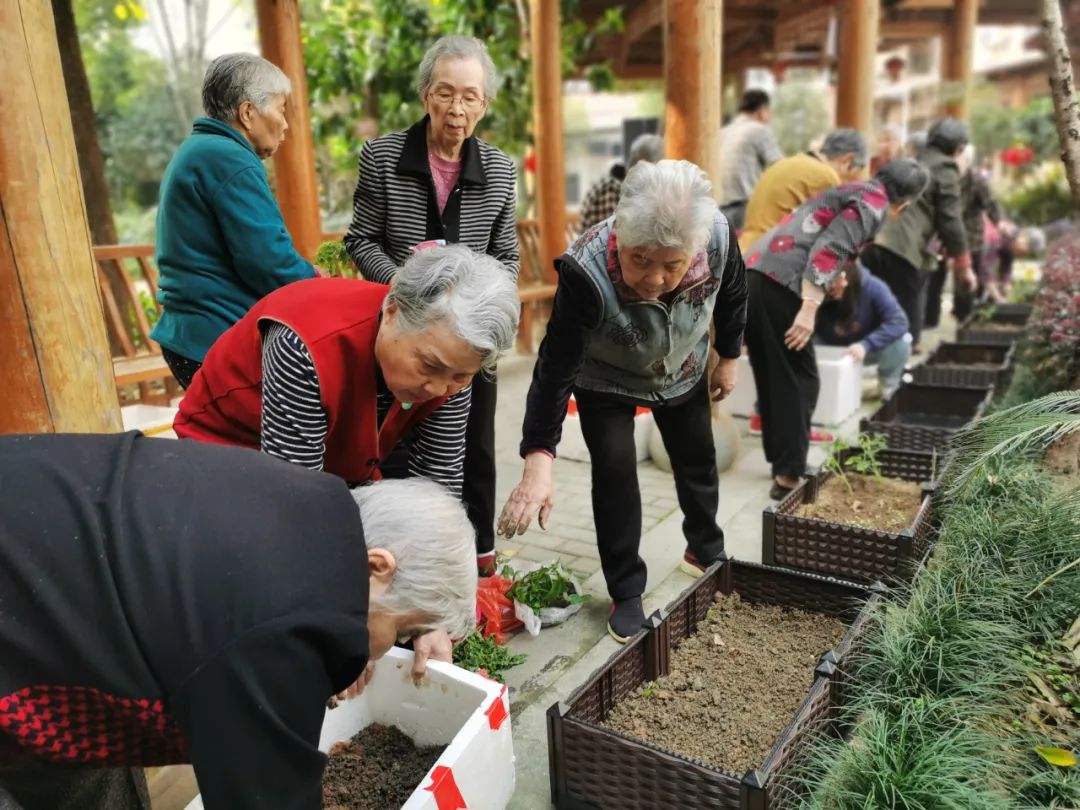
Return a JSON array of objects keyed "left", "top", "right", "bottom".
[{"left": 836, "top": 0, "right": 879, "bottom": 143}]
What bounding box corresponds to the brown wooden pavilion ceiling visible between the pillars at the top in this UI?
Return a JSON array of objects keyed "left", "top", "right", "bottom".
[{"left": 581, "top": 0, "right": 1045, "bottom": 79}]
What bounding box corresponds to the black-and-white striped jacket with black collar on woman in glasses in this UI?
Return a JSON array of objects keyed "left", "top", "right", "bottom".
[{"left": 345, "top": 116, "right": 521, "bottom": 284}]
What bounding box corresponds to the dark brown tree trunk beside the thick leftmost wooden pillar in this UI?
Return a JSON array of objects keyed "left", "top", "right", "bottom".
[{"left": 53, "top": 0, "right": 127, "bottom": 356}]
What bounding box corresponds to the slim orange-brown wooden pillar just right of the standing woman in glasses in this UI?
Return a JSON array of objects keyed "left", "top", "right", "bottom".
[{"left": 530, "top": 0, "right": 567, "bottom": 283}]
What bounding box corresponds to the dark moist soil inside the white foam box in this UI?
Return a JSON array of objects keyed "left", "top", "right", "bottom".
[{"left": 323, "top": 723, "right": 445, "bottom": 810}]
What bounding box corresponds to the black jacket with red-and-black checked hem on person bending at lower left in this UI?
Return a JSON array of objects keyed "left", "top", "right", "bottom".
[{"left": 0, "top": 433, "right": 368, "bottom": 810}]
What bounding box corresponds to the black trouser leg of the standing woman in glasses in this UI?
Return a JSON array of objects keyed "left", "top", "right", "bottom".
[{"left": 461, "top": 375, "right": 499, "bottom": 554}]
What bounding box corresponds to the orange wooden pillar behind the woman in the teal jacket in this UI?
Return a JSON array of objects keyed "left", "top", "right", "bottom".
[{"left": 255, "top": 0, "right": 323, "bottom": 259}]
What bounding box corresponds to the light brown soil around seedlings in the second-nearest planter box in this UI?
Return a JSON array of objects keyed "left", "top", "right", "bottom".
[{"left": 796, "top": 473, "right": 922, "bottom": 531}]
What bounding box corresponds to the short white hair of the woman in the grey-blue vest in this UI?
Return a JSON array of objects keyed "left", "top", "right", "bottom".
[{"left": 615, "top": 160, "right": 716, "bottom": 256}]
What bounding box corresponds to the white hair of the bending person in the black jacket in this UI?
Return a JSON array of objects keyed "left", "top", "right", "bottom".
[{"left": 352, "top": 478, "right": 476, "bottom": 638}]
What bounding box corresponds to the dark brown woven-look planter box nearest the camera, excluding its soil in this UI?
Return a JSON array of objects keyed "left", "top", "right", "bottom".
[{"left": 548, "top": 562, "right": 883, "bottom": 810}]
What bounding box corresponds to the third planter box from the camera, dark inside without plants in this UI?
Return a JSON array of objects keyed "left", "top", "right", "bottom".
[{"left": 859, "top": 383, "right": 994, "bottom": 453}]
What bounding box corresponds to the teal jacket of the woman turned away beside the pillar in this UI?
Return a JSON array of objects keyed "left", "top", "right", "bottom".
[{"left": 150, "top": 118, "right": 315, "bottom": 363}]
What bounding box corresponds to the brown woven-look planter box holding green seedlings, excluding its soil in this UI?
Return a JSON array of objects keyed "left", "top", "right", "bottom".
[{"left": 761, "top": 449, "right": 942, "bottom": 584}]
